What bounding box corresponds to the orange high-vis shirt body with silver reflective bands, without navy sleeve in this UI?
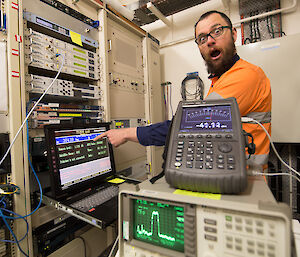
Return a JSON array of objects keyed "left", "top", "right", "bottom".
[{"left": 206, "top": 59, "right": 272, "bottom": 167}]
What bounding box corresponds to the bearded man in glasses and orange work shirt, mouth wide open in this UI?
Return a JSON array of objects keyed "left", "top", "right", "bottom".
[{"left": 97, "top": 11, "right": 272, "bottom": 166}]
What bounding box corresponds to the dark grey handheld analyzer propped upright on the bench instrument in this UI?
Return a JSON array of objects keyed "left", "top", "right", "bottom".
[{"left": 165, "top": 97, "right": 247, "bottom": 194}]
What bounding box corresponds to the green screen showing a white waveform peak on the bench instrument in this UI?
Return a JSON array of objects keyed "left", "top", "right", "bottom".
[{"left": 133, "top": 199, "right": 184, "bottom": 252}]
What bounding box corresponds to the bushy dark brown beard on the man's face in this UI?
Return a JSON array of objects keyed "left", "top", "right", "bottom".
[{"left": 201, "top": 40, "right": 236, "bottom": 77}]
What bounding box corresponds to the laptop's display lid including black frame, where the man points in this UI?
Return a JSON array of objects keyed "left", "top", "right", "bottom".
[{"left": 45, "top": 123, "right": 115, "bottom": 198}]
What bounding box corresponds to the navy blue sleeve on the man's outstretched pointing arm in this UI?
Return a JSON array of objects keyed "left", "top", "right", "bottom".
[{"left": 137, "top": 120, "right": 171, "bottom": 146}]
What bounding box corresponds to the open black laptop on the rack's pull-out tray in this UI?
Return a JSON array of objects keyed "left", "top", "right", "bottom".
[{"left": 44, "top": 123, "right": 118, "bottom": 227}]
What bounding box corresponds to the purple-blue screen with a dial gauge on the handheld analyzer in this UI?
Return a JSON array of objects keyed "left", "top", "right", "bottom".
[{"left": 180, "top": 105, "right": 232, "bottom": 132}]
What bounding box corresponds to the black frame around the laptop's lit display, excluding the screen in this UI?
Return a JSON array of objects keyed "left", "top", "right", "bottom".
[{"left": 44, "top": 123, "right": 116, "bottom": 200}]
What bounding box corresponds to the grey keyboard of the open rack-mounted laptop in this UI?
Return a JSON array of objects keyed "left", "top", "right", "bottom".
[{"left": 70, "top": 186, "right": 119, "bottom": 212}]
